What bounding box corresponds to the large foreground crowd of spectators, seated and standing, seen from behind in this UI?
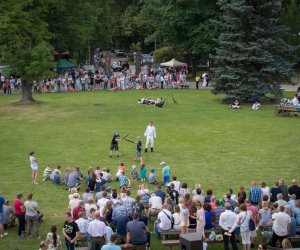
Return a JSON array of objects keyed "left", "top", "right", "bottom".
[{"left": 0, "top": 162, "right": 300, "bottom": 250}]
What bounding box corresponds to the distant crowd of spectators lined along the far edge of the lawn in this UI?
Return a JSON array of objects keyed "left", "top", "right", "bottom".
[{"left": 1, "top": 65, "right": 189, "bottom": 94}]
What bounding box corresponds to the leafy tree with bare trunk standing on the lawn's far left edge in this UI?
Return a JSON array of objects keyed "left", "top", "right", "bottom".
[{"left": 0, "top": 0, "right": 53, "bottom": 103}]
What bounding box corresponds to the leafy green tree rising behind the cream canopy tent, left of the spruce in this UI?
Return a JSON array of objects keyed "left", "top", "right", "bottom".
[{"left": 140, "top": 0, "right": 219, "bottom": 73}]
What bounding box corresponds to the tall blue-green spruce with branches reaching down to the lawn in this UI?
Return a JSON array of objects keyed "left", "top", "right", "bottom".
[{"left": 212, "top": 0, "right": 294, "bottom": 101}]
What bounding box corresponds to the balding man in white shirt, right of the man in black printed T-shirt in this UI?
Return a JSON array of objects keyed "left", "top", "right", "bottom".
[{"left": 88, "top": 211, "right": 106, "bottom": 250}]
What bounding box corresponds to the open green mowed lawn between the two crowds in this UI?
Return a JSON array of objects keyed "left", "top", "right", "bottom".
[{"left": 0, "top": 90, "right": 300, "bottom": 250}]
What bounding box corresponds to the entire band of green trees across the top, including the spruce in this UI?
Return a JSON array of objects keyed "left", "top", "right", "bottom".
[{"left": 0, "top": 0, "right": 300, "bottom": 101}]
